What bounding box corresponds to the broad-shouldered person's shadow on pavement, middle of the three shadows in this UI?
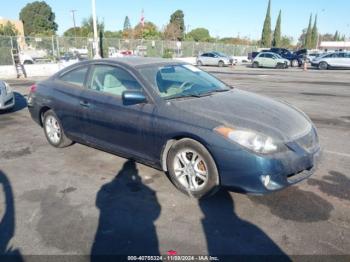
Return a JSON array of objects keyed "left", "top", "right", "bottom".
[{"left": 91, "top": 160, "right": 161, "bottom": 261}]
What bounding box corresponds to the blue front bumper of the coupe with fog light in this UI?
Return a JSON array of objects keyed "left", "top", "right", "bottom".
[{"left": 209, "top": 139, "right": 321, "bottom": 195}]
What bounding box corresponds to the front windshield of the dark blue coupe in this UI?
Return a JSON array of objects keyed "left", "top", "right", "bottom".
[{"left": 139, "top": 65, "right": 230, "bottom": 99}]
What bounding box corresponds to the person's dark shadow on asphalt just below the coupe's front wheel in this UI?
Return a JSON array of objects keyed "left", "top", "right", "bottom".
[{"left": 199, "top": 189, "right": 289, "bottom": 261}]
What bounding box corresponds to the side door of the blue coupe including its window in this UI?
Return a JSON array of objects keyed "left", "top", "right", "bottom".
[{"left": 80, "top": 64, "right": 155, "bottom": 161}]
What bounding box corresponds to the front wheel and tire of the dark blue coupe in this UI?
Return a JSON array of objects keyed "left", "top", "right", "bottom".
[{"left": 167, "top": 139, "right": 219, "bottom": 198}]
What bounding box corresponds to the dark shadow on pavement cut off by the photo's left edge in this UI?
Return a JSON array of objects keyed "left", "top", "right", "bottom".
[{"left": 0, "top": 170, "right": 23, "bottom": 262}]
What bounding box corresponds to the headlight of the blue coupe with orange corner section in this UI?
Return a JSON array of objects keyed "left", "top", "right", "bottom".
[{"left": 214, "top": 126, "right": 286, "bottom": 154}]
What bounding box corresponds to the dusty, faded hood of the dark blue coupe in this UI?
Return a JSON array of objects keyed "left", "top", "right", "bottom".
[{"left": 174, "top": 89, "right": 312, "bottom": 142}]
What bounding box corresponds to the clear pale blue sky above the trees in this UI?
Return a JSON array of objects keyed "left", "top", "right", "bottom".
[{"left": 0, "top": 0, "right": 350, "bottom": 40}]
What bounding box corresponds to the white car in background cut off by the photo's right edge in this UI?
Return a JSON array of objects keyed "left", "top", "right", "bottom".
[{"left": 311, "top": 52, "right": 350, "bottom": 70}]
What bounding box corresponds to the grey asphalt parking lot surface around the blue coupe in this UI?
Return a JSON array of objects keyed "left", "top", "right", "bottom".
[{"left": 0, "top": 66, "right": 350, "bottom": 256}]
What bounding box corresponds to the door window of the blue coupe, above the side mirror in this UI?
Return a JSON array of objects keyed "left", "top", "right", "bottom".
[{"left": 89, "top": 65, "right": 141, "bottom": 96}]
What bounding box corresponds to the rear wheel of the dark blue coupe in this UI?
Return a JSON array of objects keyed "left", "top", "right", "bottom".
[{"left": 43, "top": 110, "right": 73, "bottom": 148}]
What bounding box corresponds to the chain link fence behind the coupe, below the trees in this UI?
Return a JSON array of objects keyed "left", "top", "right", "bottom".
[{"left": 0, "top": 36, "right": 257, "bottom": 65}]
